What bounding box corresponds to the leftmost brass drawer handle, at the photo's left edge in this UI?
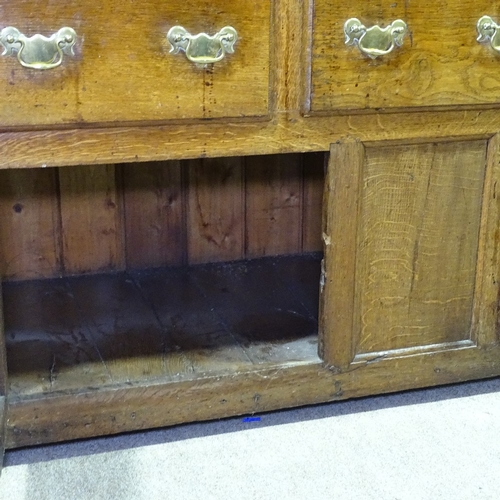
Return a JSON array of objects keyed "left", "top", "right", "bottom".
[{"left": 0, "top": 26, "right": 76, "bottom": 69}]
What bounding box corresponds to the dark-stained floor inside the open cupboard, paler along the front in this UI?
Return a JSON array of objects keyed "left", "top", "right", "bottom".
[{"left": 3, "top": 253, "right": 321, "bottom": 399}]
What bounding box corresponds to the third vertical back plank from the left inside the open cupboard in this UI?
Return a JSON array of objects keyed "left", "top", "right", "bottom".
[{"left": 122, "top": 161, "right": 186, "bottom": 269}]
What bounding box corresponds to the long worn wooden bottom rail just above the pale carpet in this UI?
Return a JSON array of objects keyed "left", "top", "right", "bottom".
[{"left": 5, "top": 346, "right": 500, "bottom": 448}]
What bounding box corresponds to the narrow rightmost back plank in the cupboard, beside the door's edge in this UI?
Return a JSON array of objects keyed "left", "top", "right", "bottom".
[{"left": 302, "top": 153, "right": 325, "bottom": 252}]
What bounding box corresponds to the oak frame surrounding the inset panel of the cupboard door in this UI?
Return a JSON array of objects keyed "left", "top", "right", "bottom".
[{"left": 319, "top": 134, "right": 500, "bottom": 376}]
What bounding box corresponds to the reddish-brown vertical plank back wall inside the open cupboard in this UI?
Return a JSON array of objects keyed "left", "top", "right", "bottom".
[{"left": 0, "top": 153, "right": 323, "bottom": 280}]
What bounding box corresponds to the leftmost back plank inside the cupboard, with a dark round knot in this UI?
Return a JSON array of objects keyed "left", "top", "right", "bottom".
[{"left": 0, "top": 169, "right": 60, "bottom": 279}]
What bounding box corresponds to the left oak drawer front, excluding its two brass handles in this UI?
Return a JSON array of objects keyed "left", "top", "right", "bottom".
[{"left": 0, "top": 0, "right": 271, "bottom": 127}]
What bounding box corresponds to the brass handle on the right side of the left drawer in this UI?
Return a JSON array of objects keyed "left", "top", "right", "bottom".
[{"left": 167, "top": 26, "right": 238, "bottom": 66}]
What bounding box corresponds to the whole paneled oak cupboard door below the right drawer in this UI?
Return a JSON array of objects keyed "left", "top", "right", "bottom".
[{"left": 320, "top": 136, "right": 500, "bottom": 389}]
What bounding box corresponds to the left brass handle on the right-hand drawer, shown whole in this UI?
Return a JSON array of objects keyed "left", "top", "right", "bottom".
[{"left": 344, "top": 18, "right": 408, "bottom": 59}]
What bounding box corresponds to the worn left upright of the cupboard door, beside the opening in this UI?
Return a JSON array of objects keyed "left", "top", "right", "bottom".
[{"left": 319, "top": 140, "right": 365, "bottom": 369}]
